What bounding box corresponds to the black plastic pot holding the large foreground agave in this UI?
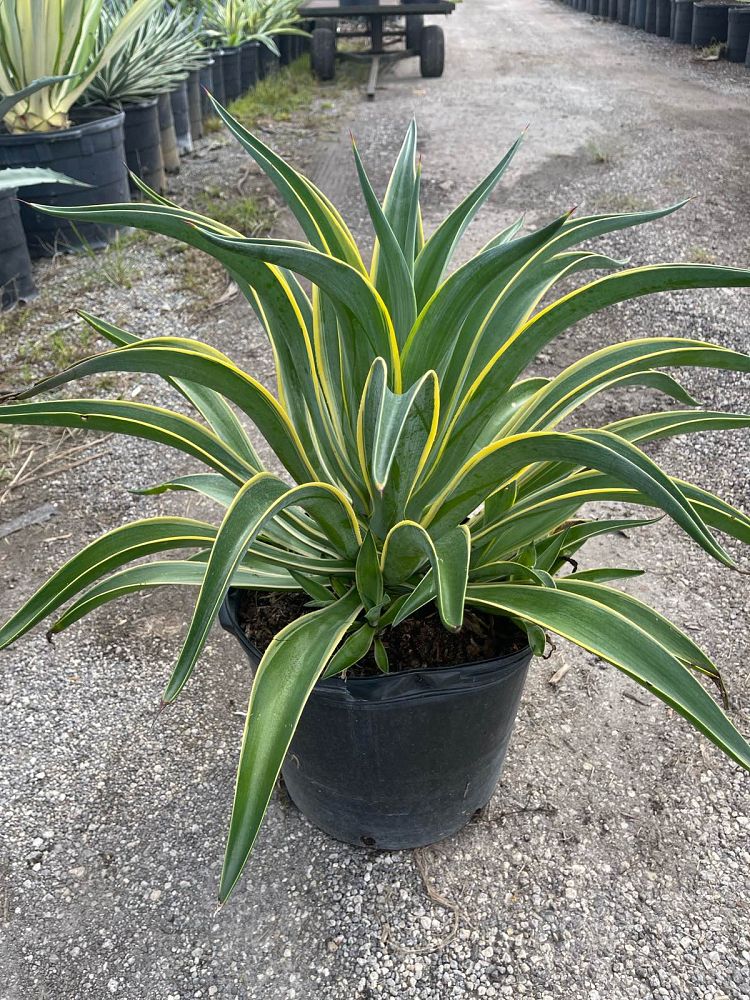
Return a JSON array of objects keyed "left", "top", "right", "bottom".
[{"left": 220, "top": 590, "right": 531, "bottom": 850}]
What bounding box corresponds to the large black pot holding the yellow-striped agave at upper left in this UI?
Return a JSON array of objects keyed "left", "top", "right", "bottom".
[{"left": 0, "top": 106, "right": 130, "bottom": 257}]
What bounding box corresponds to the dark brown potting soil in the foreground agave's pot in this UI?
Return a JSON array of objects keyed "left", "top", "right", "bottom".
[{"left": 238, "top": 590, "right": 526, "bottom": 677}]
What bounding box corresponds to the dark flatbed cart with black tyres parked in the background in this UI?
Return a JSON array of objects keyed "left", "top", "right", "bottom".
[{"left": 299, "top": 0, "right": 455, "bottom": 98}]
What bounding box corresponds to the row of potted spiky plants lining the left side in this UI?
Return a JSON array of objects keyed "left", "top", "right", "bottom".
[{"left": 0, "top": 0, "right": 304, "bottom": 308}]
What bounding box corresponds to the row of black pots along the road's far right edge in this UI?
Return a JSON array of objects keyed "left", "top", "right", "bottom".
[{"left": 562, "top": 0, "right": 750, "bottom": 67}]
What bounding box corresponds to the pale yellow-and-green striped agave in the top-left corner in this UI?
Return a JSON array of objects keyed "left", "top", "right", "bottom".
[{"left": 0, "top": 0, "right": 162, "bottom": 132}]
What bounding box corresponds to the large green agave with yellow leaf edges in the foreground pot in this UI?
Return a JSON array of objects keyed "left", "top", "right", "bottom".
[{"left": 0, "top": 109, "right": 750, "bottom": 900}]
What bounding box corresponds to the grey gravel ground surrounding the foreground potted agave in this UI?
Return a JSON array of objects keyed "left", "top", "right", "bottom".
[{"left": 0, "top": 0, "right": 750, "bottom": 1000}]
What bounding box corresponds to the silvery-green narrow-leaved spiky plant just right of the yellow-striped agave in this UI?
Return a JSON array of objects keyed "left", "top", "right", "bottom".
[{"left": 84, "top": 0, "right": 210, "bottom": 104}]
